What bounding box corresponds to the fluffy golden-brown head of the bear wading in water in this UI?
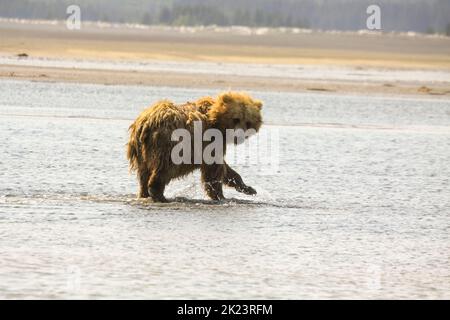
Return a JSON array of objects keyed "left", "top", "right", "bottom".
[{"left": 208, "top": 92, "right": 262, "bottom": 132}]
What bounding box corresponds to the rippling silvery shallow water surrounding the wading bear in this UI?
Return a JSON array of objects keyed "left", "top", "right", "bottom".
[{"left": 0, "top": 81, "right": 450, "bottom": 299}]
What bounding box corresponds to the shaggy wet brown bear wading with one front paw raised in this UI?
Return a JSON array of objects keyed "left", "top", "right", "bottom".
[{"left": 127, "top": 92, "right": 262, "bottom": 202}]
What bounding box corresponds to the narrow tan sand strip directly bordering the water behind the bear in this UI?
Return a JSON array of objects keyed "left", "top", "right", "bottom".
[{"left": 0, "top": 65, "right": 450, "bottom": 96}]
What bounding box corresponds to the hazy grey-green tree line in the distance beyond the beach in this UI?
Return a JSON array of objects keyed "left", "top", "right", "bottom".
[{"left": 0, "top": 0, "right": 450, "bottom": 34}]
